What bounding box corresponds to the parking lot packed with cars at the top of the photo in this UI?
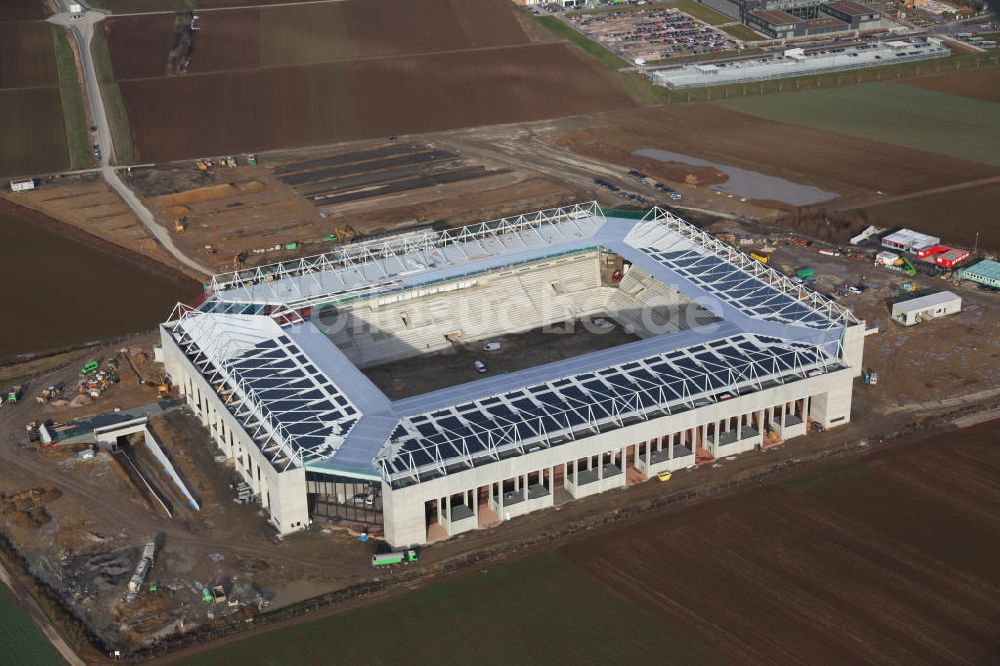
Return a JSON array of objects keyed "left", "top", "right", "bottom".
[{"left": 569, "top": 7, "right": 740, "bottom": 62}]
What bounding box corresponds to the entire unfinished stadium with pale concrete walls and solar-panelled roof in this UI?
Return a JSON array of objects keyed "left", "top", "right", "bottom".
[{"left": 161, "top": 203, "right": 864, "bottom": 547}]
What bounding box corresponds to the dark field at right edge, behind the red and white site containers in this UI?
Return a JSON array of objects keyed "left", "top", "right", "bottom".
[{"left": 864, "top": 183, "right": 1000, "bottom": 250}]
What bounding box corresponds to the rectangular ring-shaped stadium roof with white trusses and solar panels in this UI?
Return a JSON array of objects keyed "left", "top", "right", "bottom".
[{"left": 165, "top": 204, "right": 859, "bottom": 483}]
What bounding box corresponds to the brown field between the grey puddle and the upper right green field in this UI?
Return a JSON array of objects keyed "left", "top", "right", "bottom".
[{"left": 550, "top": 104, "right": 1000, "bottom": 196}]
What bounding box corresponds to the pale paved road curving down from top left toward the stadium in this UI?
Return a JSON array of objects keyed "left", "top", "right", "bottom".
[{"left": 49, "top": 0, "right": 214, "bottom": 275}]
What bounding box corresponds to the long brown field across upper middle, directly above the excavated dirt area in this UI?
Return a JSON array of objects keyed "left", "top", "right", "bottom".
[{"left": 121, "top": 44, "right": 632, "bottom": 161}]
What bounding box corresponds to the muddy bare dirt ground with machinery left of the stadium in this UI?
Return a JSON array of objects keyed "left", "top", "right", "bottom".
[{"left": 0, "top": 350, "right": 382, "bottom": 647}]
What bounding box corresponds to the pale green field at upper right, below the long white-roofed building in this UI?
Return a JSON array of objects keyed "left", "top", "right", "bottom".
[{"left": 717, "top": 83, "right": 1000, "bottom": 166}]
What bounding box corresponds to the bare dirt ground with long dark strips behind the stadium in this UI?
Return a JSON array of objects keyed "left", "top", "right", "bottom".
[{"left": 133, "top": 139, "right": 573, "bottom": 271}]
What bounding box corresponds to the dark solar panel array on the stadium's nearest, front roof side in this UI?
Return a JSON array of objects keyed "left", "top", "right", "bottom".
[{"left": 379, "top": 334, "right": 836, "bottom": 478}]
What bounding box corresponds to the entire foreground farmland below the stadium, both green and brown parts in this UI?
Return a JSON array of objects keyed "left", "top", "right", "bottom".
[{"left": 176, "top": 422, "right": 1000, "bottom": 665}]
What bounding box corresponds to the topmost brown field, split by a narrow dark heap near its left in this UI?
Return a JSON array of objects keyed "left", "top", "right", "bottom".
[{"left": 106, "top": 0, "right": 529, "bottom": 79}]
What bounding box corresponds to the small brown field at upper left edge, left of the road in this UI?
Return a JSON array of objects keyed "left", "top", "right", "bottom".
[{"left": 0, "top": 22, "right": 59, "bottom": 88}]
